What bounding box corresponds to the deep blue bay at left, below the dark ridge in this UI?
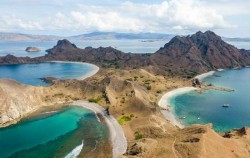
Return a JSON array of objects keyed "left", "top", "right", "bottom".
[{"left": 0, "top": 62, "right": 94, "bottom": 86}]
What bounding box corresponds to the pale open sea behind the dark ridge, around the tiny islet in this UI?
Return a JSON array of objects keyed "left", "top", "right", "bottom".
[{"left": 0, "top": 39, "right": 250, "bottom": 57}]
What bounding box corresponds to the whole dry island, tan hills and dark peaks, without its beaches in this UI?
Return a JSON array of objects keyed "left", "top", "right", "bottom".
[{"left": 0, "top": 31, "right": 250, "bottom": 158}]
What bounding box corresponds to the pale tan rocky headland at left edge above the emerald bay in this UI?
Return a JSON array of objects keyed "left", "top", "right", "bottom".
[{"left": 0, "top": 79, "right": 45, "bottom": 126}]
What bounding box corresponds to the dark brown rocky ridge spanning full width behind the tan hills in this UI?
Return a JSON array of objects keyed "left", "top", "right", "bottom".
[{"left": 0, "top": 31, "right": 250, "bottom": 78}]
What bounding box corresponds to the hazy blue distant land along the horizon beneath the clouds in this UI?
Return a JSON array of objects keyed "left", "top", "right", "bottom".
[{"left": 0, "top": 32, "right": 250, "bottom": 42}]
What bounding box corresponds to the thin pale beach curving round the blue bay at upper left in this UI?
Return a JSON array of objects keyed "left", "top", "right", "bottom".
[{"left": 46, "top": 61, "right": 100, "bottom": 80}]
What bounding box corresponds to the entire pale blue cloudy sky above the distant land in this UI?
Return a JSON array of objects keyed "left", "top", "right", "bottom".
[{"left": 0, "top": 0, "right": 250, "bottom": 37}]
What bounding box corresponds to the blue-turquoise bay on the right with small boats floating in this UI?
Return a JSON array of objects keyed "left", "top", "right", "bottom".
[{"left": 173, "top": 68, "right": 250, "bottom": 131}]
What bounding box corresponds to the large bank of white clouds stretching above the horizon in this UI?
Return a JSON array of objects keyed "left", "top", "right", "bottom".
[{"left": 1, "top": 0, "right": 235, "bottom": 32}]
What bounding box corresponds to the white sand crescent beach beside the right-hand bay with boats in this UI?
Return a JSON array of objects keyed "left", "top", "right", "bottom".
[{"left": 158, "top": 87, "right": 197, "bottom": 128}]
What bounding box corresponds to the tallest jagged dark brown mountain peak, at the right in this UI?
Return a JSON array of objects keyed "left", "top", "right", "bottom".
[{"left": 151, "top": 31, "right": 250, "bottom": 73}]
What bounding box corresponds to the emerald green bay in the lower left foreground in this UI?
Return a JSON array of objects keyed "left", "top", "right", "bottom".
[{"left": 0, "top": 106, "right": 109, "bottom": 158}]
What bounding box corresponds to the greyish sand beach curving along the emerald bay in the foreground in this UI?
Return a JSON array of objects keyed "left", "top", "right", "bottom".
[{"left": 72, "top": 101, "right": 127, "bottom": 158}]
